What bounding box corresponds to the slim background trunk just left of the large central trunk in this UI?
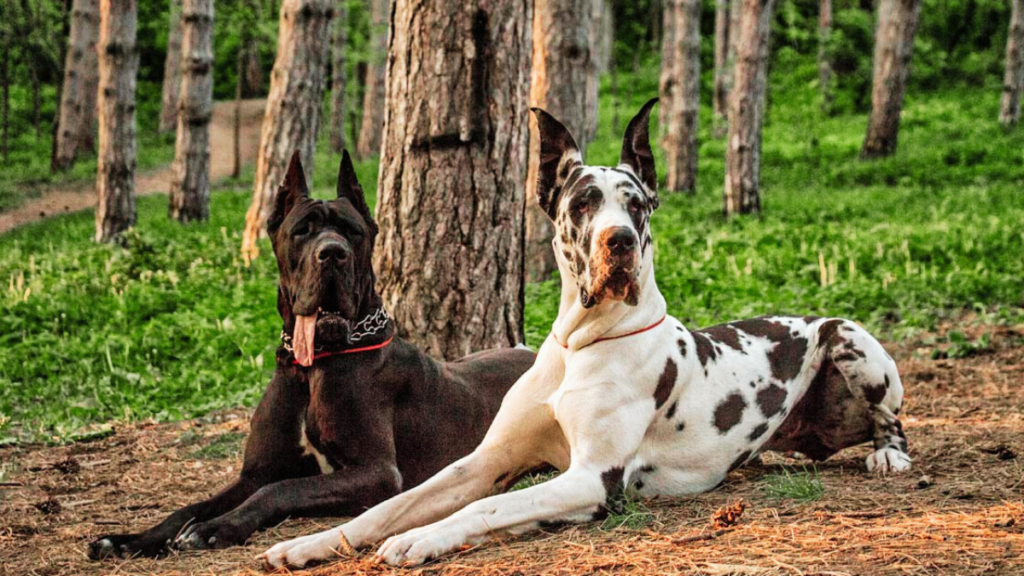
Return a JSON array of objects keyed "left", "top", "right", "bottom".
[{"left": 356, "top": 0, "right": 391, "bottom": 158}]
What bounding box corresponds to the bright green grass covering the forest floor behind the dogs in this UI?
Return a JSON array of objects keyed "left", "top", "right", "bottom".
[{"left": 0, "top": 59, "right": 1024, "bottom": 441}]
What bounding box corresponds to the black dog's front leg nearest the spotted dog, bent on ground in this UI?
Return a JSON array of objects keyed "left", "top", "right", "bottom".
[{"left": 174, "top": 462, "right": 401, "bottom": 549}]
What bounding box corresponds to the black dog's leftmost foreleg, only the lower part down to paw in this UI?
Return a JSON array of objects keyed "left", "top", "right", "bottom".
[{"left": 89, "top": 478, "right": 260, "bottom": 560}]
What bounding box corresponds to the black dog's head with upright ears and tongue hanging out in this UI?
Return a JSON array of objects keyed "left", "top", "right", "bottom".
[{"left": 267, "top": 152, "right": 381, "bottom": 366}]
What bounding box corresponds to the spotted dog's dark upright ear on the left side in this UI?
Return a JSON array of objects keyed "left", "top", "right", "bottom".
[{"left": 530, "top": 108, "right": 583, "bottom": 219}]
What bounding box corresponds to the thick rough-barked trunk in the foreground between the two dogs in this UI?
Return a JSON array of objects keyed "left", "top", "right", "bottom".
[{"left": 374, "top": 0, "right": 536, "bottom": 359}]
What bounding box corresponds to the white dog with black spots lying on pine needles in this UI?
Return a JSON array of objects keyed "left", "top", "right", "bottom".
[{"left": 263, "top": 100, "right": 910, "bottom": 567}]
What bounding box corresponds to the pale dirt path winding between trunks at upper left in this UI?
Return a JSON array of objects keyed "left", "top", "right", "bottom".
[{"left": 0, "top": 99, "right": 266, "bottom": 234}]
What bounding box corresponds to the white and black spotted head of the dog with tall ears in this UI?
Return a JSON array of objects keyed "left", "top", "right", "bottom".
[{"left": 534, "top": 98, "right": 658, "bottom": 307}]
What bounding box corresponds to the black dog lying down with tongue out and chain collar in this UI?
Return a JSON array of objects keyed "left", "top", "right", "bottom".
[{"left": 89, "top": 153, "right": 534, "bottom": 559}]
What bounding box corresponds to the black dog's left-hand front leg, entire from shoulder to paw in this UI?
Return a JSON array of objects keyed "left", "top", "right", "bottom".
[{"left": 89, "top": 363, "right": 319, "bottom": 560}]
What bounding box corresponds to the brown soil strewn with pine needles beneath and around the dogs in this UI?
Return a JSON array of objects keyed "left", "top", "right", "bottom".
[{"left": 0, "top": 326, "right": 1024, "bottom": 576}]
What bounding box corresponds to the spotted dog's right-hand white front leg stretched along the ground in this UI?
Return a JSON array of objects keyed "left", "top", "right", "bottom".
[{"left": 377, "top": 466, "right": 607, "bottom": 565}]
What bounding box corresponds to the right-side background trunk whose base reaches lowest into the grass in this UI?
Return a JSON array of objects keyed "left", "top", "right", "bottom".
[{"left": 723, "top": 0, "right": 775, "bottom": 216}]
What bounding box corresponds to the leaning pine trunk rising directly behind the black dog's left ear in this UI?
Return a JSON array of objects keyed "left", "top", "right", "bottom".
[{"left": 242, "top": 0, "right": 333, "bottom": 260}]
